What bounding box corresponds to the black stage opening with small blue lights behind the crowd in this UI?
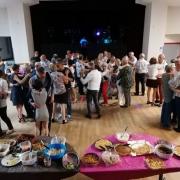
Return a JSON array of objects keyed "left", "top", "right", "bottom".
[{"left": 31, "top": 0, "right": 145, "bottom": 58}]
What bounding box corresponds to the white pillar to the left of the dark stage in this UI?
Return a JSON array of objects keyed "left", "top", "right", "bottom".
[{"left": 7, "top": 0, "right": 34, "bottom": 64}]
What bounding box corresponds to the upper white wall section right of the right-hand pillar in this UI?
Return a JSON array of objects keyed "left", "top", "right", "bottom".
[{"left": 166, "top": 7, "right": 180, "bottom": 34}]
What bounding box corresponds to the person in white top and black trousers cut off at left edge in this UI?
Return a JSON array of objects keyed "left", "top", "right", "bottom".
[{"left": 0, "top": 70, "right": 14, "bottom": 137}]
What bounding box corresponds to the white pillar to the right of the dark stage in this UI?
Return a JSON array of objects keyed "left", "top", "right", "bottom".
[{"left": 142, "top": 0, "right": 168, "bottom": 60}]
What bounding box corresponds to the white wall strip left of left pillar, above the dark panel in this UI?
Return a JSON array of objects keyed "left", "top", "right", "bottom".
[{"left": 0, "top": 7, "right": 10, "bottom": 36}]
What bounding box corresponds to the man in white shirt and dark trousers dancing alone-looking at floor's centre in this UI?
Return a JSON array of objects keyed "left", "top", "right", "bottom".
[{"left": 81, "top": 62, "right": 101, "bottom": 119}]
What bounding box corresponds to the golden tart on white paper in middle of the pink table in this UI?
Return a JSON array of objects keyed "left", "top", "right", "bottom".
[{"left": 129, "top": 140, "right": 154, "bottom": 156}]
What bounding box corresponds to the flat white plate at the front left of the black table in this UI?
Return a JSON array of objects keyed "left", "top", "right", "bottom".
[{"left": 1, "top": 154, "right": 21, "bottom": 167}]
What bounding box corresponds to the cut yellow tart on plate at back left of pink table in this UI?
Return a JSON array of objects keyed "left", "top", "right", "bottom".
[{"left": 94, "top": 139, "right": 113, "bottom": 151}]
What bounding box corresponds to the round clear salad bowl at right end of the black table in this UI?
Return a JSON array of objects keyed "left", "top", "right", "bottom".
[{"left": 62, "top": 152, "right": 80, "bottom": 170}]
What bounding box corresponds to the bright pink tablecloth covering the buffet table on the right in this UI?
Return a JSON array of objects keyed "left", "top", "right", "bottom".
[{"left": 80, "top": 134, "right": 180, "bottom": 180}]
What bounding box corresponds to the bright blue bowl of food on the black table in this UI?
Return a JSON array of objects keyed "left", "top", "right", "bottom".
[{"left": 44, "top": 144, "right": 66, "bottom": 160}]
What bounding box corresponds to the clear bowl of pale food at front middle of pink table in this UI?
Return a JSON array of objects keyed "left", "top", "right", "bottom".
[{"left": 101, "top": 151, "right": 120, "bottom": 166}]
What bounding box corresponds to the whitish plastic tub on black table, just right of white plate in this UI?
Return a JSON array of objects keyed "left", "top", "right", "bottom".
[{"left": 21, "top": 151, "right": 37, "bottom": 166}]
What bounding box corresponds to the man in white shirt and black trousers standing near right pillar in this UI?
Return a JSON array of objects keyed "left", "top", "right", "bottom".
[{"left": 135, "top": 53, "right": 148, "bottom": 96}]
